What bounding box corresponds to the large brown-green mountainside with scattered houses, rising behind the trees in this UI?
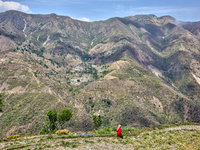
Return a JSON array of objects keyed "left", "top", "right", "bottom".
[{"left": 0, "top": 11, "right": 200, "bottom": 136}]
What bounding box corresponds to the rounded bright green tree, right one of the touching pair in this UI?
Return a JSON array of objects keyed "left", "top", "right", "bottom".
[{"left": 58, "top": 109, "right": 73, "bottom": 128}]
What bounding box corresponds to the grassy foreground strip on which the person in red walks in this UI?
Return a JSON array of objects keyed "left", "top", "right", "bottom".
[{"left": 0, "top": 125, "right": 200, "bottom": 150}]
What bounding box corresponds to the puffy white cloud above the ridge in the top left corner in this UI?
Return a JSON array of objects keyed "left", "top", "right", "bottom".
[{"left": 0, "top": 0, "right": 32, "bottom": 13}]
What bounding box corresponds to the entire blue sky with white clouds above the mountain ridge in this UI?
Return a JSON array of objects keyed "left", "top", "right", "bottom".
[{"left": 0, "top": 0, "right": 200, "bottom": 21}]
